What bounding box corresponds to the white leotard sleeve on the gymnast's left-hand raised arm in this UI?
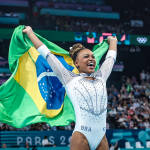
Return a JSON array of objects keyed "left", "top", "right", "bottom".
[{"left": 37, "top": 45, "right": 76, "bottom": 86}]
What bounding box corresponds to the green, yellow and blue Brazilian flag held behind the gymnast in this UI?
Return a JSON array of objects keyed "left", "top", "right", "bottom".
[{"left": 0, "top": 26, "right": 108, "bottom": 128}]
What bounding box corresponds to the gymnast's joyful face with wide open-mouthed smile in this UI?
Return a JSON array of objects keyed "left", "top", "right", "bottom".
[{"left": 74, "top": 49, "right": 96, "bottom": 74}]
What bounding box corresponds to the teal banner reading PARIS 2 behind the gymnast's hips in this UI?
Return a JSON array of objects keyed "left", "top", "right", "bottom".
[{"left": 0, "top": 129, "right": 150, "bottom": 149}]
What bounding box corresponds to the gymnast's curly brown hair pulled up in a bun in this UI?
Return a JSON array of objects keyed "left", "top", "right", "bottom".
[{"left": 69, "top": 43, "right": 86, "bottom": 61}]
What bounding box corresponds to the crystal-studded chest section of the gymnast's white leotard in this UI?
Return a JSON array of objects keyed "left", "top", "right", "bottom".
[{"left": 74, "top": 78, "right": 107, "bottom": 116}]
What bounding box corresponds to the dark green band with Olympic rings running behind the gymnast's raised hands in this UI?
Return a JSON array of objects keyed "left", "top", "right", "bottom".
[{"left": 0, "top": 28, "right": 150, "bottom": 46}]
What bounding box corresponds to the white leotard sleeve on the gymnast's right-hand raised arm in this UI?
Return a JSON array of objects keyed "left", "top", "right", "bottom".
[{"left": 100, "top": 50, "right": 117, "bottom": 81}]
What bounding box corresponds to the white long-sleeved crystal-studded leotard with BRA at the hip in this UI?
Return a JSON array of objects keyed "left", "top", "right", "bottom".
[{"left": 38, "top": 45, "right": 116, "bottom": 150}]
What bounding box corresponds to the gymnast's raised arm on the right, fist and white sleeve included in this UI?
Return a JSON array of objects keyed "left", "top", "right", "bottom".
[{"left": 100, "top": 37, "right": 117, "bottom": 81}]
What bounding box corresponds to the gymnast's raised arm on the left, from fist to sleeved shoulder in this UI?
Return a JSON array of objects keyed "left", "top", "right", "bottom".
[{"left": 23, "top": 26, "right": 73, "bottom": 86}]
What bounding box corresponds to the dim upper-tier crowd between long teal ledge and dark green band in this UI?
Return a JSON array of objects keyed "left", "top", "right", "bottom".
[{"left": 38, "top": 13, "right": 125, "bottom": 34}]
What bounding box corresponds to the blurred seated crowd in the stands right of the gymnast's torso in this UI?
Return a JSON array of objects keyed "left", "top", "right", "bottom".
[{"left": 107, "top": 70, "right": 150, "bottom": 129}]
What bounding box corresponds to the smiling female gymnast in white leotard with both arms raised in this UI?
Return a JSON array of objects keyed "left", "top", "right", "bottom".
[{"left": 23, "top": 26, "right": 117, "bottom": 150}]
